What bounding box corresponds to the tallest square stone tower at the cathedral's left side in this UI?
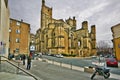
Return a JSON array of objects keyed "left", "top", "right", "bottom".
[{"left": 40, "top": 0, "right": 52, "bottom": 52}]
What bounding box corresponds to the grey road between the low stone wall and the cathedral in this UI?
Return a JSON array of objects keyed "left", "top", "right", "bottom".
[{"left": 43, "top": 55, "right": 120, "bottom": 75}]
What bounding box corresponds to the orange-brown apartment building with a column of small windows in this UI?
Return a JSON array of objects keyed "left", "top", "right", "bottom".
[{"left": 9, "top": 19, "right": 30, "bottom": 55}]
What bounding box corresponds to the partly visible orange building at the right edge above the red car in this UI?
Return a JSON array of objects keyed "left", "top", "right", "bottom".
[{"left": 111, "top": 24, "right": 120, "bottom": 61}]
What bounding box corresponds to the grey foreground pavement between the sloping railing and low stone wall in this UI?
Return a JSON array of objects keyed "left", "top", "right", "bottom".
[{"left": 20, "top": 60, "right": 118, "bottom": 80}]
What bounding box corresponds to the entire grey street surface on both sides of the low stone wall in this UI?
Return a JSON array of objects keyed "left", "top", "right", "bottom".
[{"left": 13, "top": 56, "right": 119, "bottom": 80}]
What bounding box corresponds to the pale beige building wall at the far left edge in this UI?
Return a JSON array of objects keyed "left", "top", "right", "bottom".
[{"left": 0, "top": 0, "right": 10, "bottom": 57}]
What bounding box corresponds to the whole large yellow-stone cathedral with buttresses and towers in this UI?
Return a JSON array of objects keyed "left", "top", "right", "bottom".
[{"left": 36, "top": 0, "right": 96, "bottom": 57}]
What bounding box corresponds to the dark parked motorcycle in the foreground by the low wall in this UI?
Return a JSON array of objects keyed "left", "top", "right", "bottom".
[{"left": 91, "top": 65, "right": 110, "bottom": 79}]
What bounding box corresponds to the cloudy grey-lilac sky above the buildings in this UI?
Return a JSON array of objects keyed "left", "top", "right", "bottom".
[{"left": 8, "top": 0, "right": 120, "bottom": 46}]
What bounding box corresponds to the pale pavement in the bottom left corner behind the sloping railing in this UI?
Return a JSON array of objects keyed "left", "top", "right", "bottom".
[{"left": 0, "top": 61, "right": 40, "bottom": 80}]
